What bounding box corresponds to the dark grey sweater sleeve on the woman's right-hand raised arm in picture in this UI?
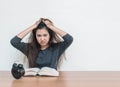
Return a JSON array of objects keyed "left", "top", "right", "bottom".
[{"left": 59, "top": 34, "right": 73, "bottom": 54}]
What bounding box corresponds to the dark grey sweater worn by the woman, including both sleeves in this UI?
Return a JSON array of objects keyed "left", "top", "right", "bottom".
[{"left": 11, "top": 34, "right": 73, "bottom": 69}]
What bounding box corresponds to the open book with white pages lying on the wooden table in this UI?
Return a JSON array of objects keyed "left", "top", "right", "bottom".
[{"left": 24, "top": 67, "right": 59, "bottom": 76}]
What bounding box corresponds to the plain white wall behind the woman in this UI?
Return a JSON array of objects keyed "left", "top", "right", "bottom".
[{"left": 0, "top": 0, "right": 120, "bottom": 71}]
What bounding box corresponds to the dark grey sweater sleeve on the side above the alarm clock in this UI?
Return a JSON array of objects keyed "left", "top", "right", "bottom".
[{"left": 10, "top": 36, "right": 27, "bottom": 56}]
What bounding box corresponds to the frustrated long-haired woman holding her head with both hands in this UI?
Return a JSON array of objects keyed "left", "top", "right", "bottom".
[{"left": 11, "top": 18, "right": 73, "bottom": 69}]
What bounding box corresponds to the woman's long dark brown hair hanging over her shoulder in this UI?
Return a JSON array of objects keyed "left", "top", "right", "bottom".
[{"left": 27, "top": 19, "right": 61, "bottom": 68}]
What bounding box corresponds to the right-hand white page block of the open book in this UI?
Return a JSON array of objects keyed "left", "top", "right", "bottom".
[{"left": 38, "top": 67, "right": 59, "bottom": 76}]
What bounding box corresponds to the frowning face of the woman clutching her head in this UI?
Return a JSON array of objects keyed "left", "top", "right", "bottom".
[{"left": 36, "top": 28, "right": 50, "bottom": 49}]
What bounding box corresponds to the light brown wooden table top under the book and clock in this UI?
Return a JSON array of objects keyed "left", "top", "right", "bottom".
[{"left": 0, "top": 71, "right": 120, "bottom": 87}]
